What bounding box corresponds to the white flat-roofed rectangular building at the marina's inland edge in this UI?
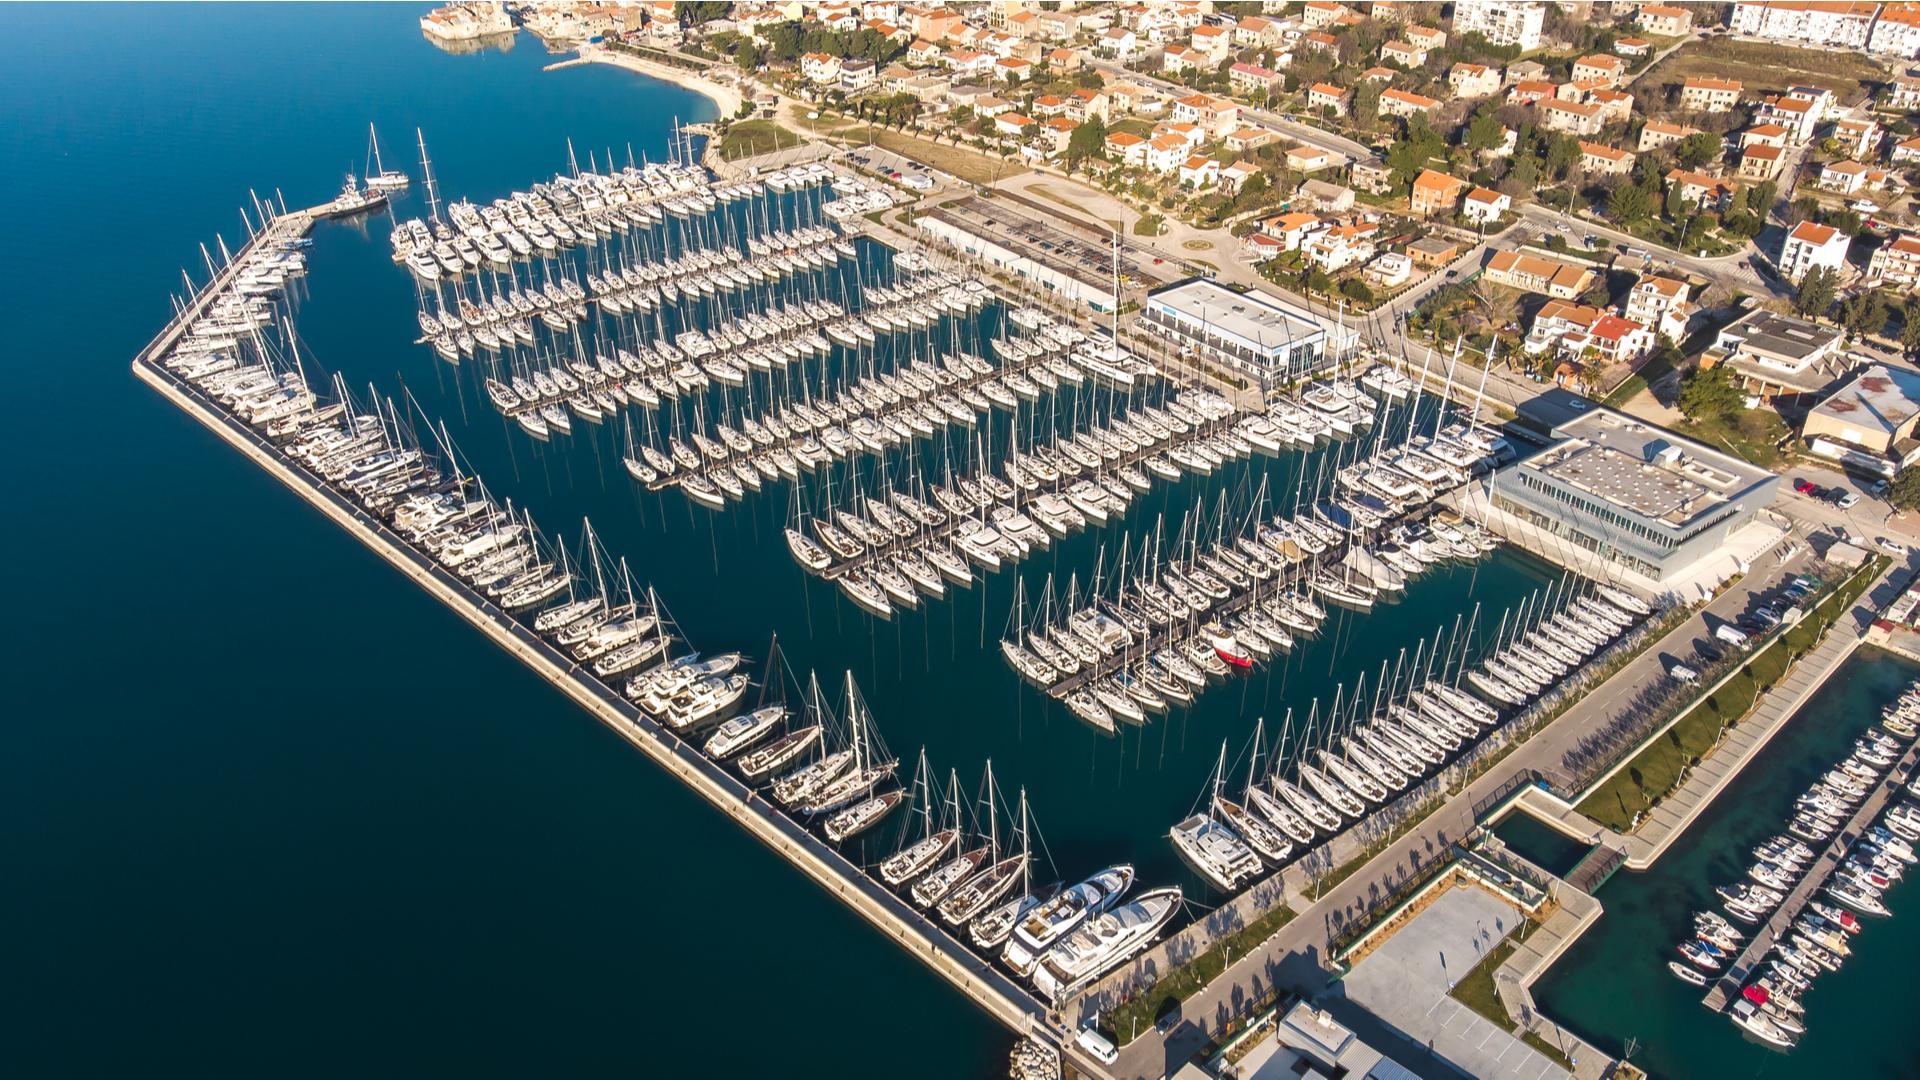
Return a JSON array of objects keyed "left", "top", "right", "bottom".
[{"left": 1142, "top": 277, "right": 1359, "bottom": 390}]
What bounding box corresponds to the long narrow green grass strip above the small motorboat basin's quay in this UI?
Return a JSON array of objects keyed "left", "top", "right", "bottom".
[{"left": 1576, "top": 559, "right": 1882, "bottom": 832}]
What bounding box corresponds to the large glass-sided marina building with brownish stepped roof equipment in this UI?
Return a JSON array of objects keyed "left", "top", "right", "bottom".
[{"left": 1492, "top": 392, "right": 1780, "bottom": 582}]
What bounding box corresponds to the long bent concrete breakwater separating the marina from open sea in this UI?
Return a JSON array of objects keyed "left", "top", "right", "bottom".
[{"left": 132, "top": 195, "right": 1071, "bottom": 1045}]
